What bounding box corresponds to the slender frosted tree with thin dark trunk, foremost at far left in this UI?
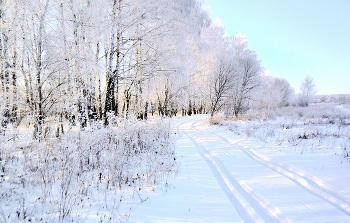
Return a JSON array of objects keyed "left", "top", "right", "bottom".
[{"left": 18, "top": 0, "right": 65, "bottom": 140}]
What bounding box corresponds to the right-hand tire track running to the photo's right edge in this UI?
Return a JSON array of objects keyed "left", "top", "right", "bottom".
[{"left": 210, "top": 131, "right": 350, "bottom": 216}]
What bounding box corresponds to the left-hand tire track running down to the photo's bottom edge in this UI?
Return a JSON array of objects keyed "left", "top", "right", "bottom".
[{"left": 183, "top": 126, "right": 290, "bottom": 222}]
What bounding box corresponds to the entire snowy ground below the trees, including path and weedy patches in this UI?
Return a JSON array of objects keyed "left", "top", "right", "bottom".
[{"left": 0, "top": 105, "right": 350, "bottom": 222}]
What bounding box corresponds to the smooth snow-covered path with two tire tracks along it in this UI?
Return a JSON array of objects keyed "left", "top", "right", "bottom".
[{"left": 130, "top": 115, "right": 350, "bottom": 222}]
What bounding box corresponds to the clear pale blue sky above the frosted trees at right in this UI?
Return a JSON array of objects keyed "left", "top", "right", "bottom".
[{"left": 205, "top": 0, "right": 350, "bottom": 95}]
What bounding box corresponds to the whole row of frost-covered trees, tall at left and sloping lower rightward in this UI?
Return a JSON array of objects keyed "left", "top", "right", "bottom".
[{"left": 0, "top": 0, "right": 310, "bottom": 139}]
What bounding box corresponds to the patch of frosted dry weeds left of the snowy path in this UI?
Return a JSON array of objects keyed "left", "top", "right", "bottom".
[{"left": 0, "top": 117, "right": 177, "bottom": 222}]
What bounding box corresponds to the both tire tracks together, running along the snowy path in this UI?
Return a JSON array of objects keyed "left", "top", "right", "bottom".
[{"left": 177, "top": 117, "right": 350, "bottom": 222}]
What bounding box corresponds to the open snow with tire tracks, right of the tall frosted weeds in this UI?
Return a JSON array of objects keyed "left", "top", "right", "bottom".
[{"left": 128, "top": 115, "right": 350, "bottom": 222}]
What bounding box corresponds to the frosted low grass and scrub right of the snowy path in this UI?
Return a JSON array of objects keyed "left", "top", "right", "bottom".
[{"left": 218, "top": 104, "right": 350, "bottom": 161}]
